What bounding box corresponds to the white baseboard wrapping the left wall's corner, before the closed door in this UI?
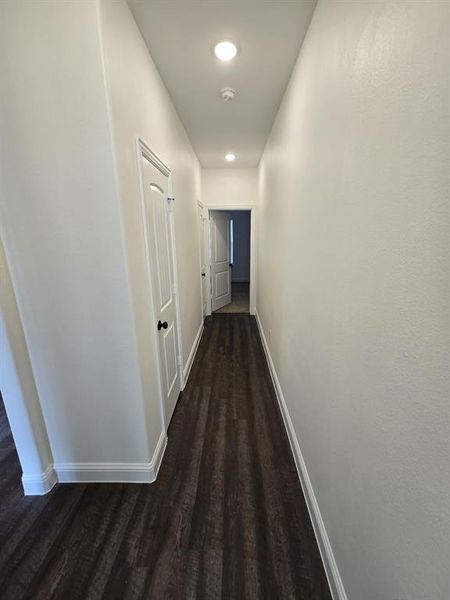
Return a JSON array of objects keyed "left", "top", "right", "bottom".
[{"left": 54, "top": 431, "right": 167, "bottom": 483}]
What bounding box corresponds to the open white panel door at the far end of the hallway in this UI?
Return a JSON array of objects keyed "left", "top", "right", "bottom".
[{"left": 210, "top": 211, "right": 231, "bottom": 311}]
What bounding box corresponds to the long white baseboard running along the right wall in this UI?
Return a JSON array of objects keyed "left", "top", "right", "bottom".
[{"left": 255, "top": 311, "right": 348, "bottom": 600}]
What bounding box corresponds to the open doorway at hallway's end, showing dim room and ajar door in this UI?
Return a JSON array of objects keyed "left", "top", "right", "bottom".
[{"left": 209, "top": 210, "right": 251, "bottom": 314}]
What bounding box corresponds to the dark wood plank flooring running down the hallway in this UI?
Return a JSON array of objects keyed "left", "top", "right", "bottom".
[{"left": 0, "top": 315, "right": 331, "bottom": 600}]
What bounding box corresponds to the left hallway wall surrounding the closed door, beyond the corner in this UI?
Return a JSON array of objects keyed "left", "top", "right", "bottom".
[{"left": 100, "top": 0, "right": 202, "bottom": 439}]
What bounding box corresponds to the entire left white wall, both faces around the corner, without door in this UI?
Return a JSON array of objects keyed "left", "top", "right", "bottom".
[{"left": 0, "top": 0, "right": 202, "bottom": 479}]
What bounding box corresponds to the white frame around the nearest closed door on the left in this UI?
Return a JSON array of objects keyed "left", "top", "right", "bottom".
[{"left": 136, "top": 137, "right": 184, "bottom": 432}]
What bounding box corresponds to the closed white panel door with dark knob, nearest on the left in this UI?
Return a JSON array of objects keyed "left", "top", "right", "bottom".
[{"left": 142, "top": 158, "right": 181, "bottom": 427}]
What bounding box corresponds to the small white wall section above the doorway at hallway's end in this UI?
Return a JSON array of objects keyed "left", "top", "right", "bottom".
[{"left": 202, "top": 168, "right": 258, "bottom": 206}]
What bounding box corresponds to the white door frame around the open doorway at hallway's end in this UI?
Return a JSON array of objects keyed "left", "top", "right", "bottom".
[{"left": 203, "top": 204, "right": 257, "bottom": 316}]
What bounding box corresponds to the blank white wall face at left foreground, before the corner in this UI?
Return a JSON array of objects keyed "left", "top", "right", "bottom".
[{"left": 0, "top": 1, "right": 151, "bottom": 463}]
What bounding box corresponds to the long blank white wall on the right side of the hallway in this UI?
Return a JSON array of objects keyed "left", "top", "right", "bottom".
[{"left": 257, "top": 1, "right": 450, "bottom": 600}]
